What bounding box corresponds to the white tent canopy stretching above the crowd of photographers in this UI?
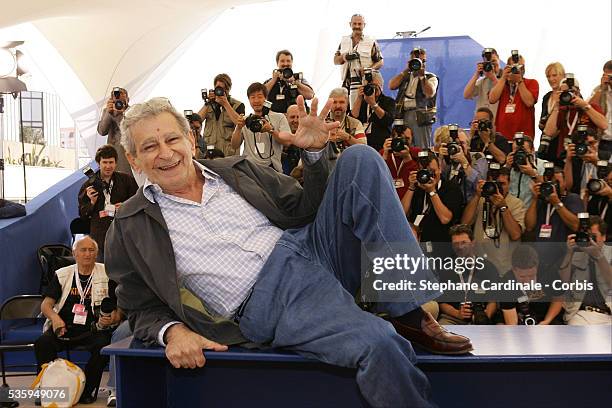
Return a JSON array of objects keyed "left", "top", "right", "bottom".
[{"left": 0, "top": 0, "right": 612, "bottom": 156}]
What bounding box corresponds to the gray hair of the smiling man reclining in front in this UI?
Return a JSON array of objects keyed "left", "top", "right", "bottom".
[{"left": 121, "top": 98, "right": 189, "bottom": 156}]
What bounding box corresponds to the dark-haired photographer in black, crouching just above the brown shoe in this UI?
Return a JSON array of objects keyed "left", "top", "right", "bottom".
[{"left": 438, "top": 224, "right": 499, "bottom": 324}]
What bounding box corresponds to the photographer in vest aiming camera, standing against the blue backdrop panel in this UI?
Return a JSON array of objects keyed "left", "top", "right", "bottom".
[{"left": 389, "top": 48, "right": 438, "bottom": 149}]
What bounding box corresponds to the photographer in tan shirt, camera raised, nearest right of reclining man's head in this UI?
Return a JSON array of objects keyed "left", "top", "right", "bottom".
[{"left": 198, "top": 74, "right": 245, "bottom": 157}]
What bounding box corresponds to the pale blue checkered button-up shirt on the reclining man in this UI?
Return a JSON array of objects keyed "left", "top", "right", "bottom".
[{"left": 143, "top": 161, "right": 283, "bottom": 318}]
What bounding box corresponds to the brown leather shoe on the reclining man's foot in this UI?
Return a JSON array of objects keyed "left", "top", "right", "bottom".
[{"left": 389, "top": 311, "right": 474, "bottom": 355}]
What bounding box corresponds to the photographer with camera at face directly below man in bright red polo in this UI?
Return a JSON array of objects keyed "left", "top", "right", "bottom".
[{"left": 470, "top": 107, "right": 512, "bottom": 167}]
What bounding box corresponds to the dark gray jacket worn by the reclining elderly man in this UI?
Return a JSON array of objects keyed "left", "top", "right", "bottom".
[{"left": 105, "top": 148, "right": 334, "bottom": 345}]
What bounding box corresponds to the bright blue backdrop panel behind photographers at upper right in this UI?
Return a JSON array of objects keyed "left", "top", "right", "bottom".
[{"left": 377, "top": 36, "right": 483, "bottom": 128}]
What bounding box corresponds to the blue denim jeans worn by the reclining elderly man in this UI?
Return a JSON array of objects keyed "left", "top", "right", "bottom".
[{"left": 240, "top": 146, "right": 439, "bottom": 407}]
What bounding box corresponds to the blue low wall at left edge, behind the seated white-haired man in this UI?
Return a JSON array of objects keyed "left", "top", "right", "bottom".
[{"left": 0, "top": 167, "right": 86, "bottom": 302}]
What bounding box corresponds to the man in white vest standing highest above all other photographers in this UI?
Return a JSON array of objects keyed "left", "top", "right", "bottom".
[{"left": 334, "top": 14, "right": 384, "bottom": 106}]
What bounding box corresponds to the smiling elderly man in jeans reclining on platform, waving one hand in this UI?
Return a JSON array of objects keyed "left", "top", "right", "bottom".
[{"left": 106, "top": 96, "right": 472, "bottom": 407}]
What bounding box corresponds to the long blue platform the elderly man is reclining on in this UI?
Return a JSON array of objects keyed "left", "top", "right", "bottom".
[{"left": 103, "top": 326, "right": 612, "bottom": 408}]
